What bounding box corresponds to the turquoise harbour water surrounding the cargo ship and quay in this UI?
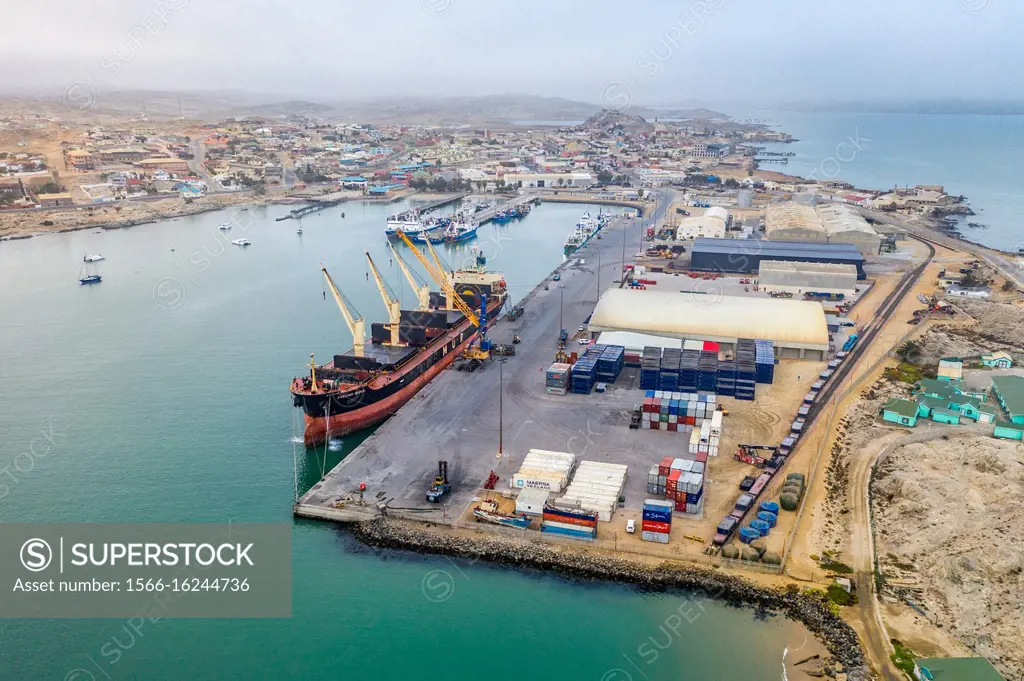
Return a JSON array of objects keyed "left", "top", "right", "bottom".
[{"left": 0, "top": 204, "right": 806, "bottom": 681}]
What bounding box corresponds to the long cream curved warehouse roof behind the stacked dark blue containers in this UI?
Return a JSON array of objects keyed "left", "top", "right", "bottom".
[{"left": 590, "top": 288, "right": 828, "bottom": 349}]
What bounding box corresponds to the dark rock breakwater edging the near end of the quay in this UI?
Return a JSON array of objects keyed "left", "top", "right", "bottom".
[{"left": 353, "top": 518, "right": 872, "bottom": 681}]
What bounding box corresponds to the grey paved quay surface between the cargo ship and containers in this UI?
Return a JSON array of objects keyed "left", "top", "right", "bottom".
[{"left": 294, "top": 218, "right": 681, "bottom": 522}]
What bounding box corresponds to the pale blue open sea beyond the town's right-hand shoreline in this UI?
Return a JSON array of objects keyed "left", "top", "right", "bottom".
[{"left": 729, "top": 110, "right": 1024, "bottom": 251}]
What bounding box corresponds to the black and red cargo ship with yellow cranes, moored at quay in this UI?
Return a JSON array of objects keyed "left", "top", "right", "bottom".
[{"left": 291, "top": 247, "right": 508, "bottom": 446}]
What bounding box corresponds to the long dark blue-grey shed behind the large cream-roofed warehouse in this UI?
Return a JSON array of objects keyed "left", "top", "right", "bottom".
[{"left": 690, "top": 239, "right": 866, "bottom": 280}]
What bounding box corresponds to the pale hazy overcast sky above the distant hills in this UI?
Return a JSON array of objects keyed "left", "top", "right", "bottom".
[{"left": 0, "top": 0, "right": 1024, "bottom": 104}]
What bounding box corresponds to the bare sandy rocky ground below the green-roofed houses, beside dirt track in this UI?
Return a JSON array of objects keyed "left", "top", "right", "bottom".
[{"left": 872, "top": 437, "right": 1024, "bottom": 678}]
